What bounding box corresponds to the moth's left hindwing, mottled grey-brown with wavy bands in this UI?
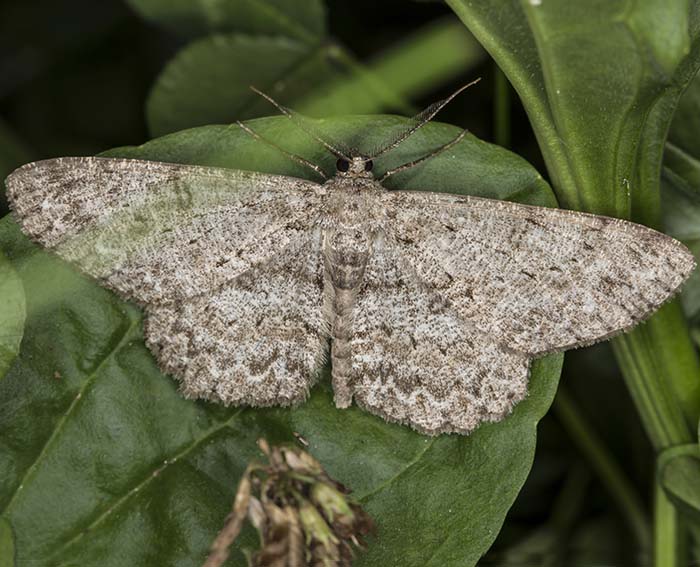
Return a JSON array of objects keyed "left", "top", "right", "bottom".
[{"left": 146, "top": 232, "right": 327, "bottom": 406}]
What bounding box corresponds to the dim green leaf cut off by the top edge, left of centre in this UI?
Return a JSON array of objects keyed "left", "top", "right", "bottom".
[{"left": 127, "top": 0, "right": 325, "bottom": 42}]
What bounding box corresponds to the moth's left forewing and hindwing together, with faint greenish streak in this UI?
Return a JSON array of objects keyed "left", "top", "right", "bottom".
[{"left": 7, "top": 158, "right": 327, "bottom": 406}]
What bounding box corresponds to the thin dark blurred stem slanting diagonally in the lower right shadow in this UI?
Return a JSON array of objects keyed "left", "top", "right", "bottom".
[{"left": 553, "top": 385, "right": 652, "bottom": 557}]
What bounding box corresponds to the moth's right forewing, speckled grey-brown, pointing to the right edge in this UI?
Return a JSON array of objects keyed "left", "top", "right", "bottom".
[{"left": 386, "top": 192, "right": 695, "bottom": 356}]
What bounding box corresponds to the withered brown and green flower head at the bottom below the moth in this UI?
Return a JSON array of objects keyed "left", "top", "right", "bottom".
[{"left": 204, "top": 439, "right": 373, "bottom": 567}]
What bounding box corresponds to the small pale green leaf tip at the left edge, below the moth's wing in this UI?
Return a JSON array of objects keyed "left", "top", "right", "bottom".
[{"left": 0, "top": 247, "right": 26, "bottom": 380}]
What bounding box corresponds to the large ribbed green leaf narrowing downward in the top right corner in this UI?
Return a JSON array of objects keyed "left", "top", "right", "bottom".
[{"left": 447, "top": 0, "right": 700, "bottom": 225}]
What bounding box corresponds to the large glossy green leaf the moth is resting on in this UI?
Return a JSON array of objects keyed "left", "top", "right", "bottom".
[{"left": 0, "top": 117, "right": 562, "bottom": 567}]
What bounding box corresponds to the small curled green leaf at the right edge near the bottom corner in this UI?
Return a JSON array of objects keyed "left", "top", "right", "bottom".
[{"left": 657, "top": 444, "right": 700, "bottom": 521}]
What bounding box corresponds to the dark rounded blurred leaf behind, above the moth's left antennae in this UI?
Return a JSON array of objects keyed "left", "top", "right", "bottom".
[{"left": 146, "top": 34, "right": 332, "bottom": 136}]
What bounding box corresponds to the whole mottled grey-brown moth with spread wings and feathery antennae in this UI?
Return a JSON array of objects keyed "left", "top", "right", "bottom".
[{"left": 6, "top": 89, "right": 695, "bottom": 434}]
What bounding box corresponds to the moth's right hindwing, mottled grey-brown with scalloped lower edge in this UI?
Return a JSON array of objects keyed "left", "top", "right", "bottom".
[{"left": 351, "top": 235, "right": 529, "bottom": 434}]
